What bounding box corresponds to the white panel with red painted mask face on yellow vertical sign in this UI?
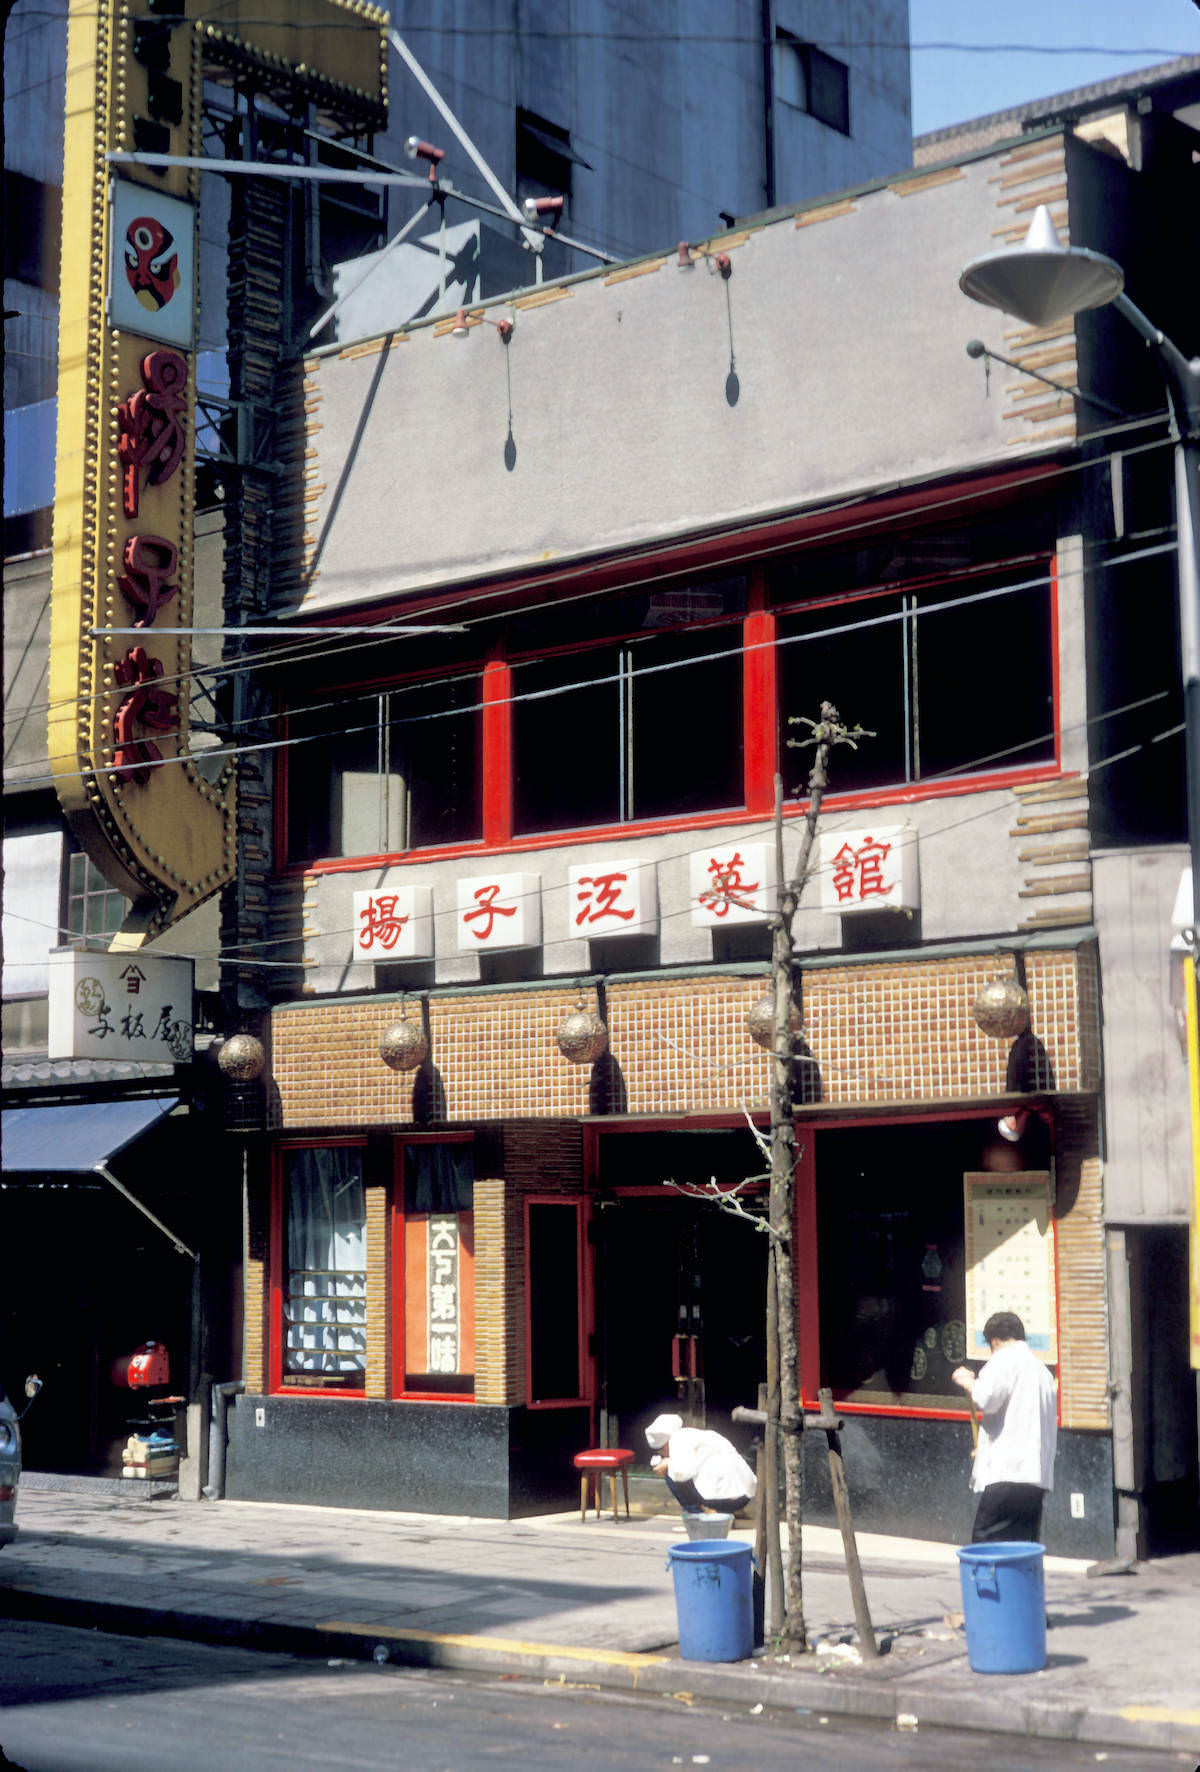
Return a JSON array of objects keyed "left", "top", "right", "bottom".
[{"left": 108, "top": 179, "right": 195, "bottom": 351}]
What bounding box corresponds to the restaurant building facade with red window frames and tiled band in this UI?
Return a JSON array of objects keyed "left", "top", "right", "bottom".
[{"left": 218, "top": 93, "right": 1195, "bottom": 1554}]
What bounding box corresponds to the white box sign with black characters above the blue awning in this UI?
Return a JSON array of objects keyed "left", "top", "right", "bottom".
[{"left": 50, "top": 950, "right": 193, "bottom": 1065}]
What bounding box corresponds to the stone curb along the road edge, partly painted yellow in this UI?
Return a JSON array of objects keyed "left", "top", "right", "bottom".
[{"left": 0, "top": 1588, "right": 1200, "bottom": 1753}]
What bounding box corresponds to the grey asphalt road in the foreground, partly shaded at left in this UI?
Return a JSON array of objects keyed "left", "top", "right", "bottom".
[{"left": 0, "top": 1623, "right": 1193, "bottom": 1772}]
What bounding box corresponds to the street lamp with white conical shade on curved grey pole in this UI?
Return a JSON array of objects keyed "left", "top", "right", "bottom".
[{"left": 959, "top": 204, "right": 1200, "bottom": 957}]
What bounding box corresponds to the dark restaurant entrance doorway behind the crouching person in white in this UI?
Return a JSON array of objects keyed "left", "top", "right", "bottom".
[{"left": 596, "top": 1131, "right": 768, "bottom": 1464}]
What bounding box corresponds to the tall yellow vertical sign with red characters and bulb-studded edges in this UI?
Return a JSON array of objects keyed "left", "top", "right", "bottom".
[{"left": 48, "top": 51, "right": 236, "bottom": 942}]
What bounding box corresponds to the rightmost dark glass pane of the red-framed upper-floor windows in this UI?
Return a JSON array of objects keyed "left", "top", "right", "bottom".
[{"left": 915, "top": 572, "right": 1055, "bottom": 780}]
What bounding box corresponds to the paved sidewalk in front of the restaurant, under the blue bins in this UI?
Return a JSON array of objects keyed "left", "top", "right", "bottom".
[{"left": 0, "top": 1476, "right": 1200, "bottom": 1754}]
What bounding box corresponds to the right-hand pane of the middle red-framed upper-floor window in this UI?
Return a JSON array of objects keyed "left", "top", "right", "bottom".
[{"left": 629, "top": 626, "right": 746, "bottom": 819}]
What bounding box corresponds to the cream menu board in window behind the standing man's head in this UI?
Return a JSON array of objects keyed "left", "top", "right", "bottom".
[{"left": 962, "top": 1170, "right": 1058, "bottom": 1366}]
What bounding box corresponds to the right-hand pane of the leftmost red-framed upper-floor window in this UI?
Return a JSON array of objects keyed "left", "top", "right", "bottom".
[{"left": 388, "top": 677, "right": 484, "bottom": 849}]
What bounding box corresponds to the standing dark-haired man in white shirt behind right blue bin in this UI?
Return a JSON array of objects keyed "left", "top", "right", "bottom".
[{"left": 952, "top": 1311, "right": 1058, "bottom": 1545}]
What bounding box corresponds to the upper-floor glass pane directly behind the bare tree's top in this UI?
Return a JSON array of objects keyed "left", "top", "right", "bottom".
[{"left": 778, "top": 597, "right": 908, "bottom": 794}]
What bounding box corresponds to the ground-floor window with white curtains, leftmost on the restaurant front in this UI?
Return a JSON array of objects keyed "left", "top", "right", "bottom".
[{"left": 280, "top": 1145, "right": 367, "bottom": 1389}]
